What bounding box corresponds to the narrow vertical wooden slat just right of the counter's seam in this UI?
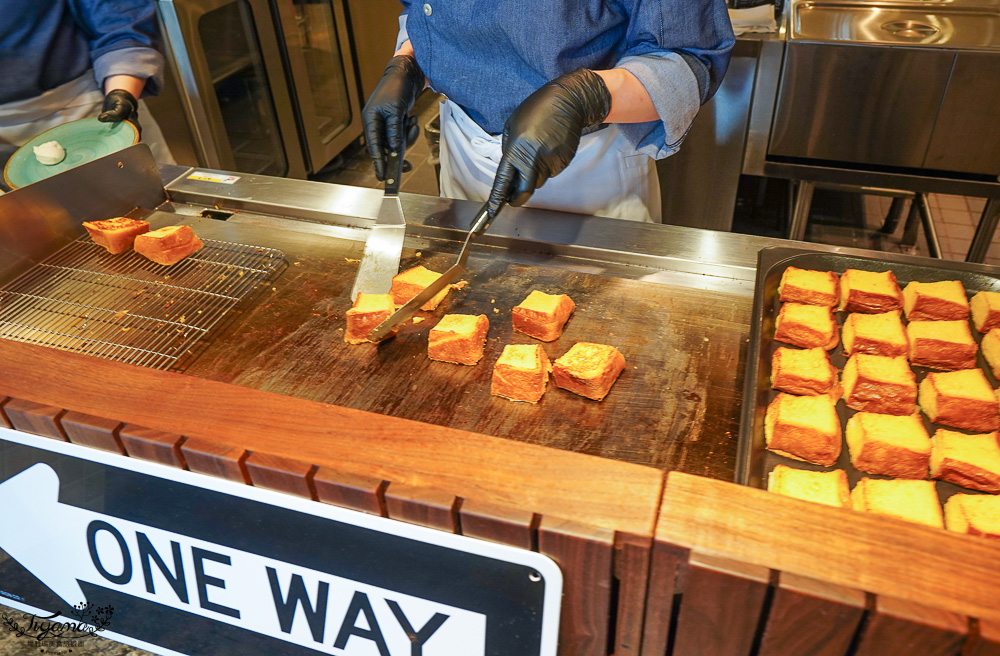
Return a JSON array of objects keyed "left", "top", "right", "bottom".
[{"left": 642, "top": 541, "right": 691, "bottom": 656}]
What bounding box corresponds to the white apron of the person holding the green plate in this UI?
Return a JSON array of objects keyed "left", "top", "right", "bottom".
[{"left": 0, "top": 71, "right": 176, "bottom": 164}]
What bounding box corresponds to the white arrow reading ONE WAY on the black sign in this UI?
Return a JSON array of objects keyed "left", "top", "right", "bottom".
[{"left": 0, "top": 463, "right": 486, "bottom": 656}]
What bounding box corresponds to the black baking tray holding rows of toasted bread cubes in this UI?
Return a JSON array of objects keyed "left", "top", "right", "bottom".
[{"left": 736, "top": 246, "right": 1000, "bottom": 504}]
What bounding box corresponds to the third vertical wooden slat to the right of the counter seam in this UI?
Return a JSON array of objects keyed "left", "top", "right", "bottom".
[{"left": 758, "top": 573, "right": 867, "bottom": 656}]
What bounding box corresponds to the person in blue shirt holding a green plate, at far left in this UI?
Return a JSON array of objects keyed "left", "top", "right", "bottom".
[{"left": 0, "top": 0, "right": 174, "bottom": 164}]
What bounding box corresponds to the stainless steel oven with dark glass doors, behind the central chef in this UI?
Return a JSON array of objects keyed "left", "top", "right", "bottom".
[{"left": 157, "top": 0, "right": 362, "bottom": 178}]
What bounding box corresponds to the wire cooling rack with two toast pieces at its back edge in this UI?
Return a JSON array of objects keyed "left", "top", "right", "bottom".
[{"left": 0, "top": 236, "right": 285, "bottom": 369}]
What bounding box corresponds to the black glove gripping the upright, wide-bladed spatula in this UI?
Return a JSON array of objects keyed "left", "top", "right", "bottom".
[{"left": 361, "top": 55, "right": 424, "bottom": 180}]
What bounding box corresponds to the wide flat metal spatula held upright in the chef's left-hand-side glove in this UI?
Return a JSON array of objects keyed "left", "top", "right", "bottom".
[{"left": 351, "top": 152, "right": 406, "bottom": 303}]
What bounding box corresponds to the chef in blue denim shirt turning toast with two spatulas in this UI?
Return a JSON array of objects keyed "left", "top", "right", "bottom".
[{"left": 363, "top": 0, "right": 734, "bottom": 222}]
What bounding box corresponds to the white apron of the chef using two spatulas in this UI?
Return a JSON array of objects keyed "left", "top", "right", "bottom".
[{"left": 441, "top": 100, "right": 661, "bottom": 223}]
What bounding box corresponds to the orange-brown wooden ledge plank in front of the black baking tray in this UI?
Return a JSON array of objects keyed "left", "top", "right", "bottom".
[{"left": 656, "top": 472, "right": 1000, "bottom": 620}]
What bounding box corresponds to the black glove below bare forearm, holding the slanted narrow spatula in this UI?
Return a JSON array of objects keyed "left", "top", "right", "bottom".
[{"left": 488, "top": 68, "right": 611, "bottom": 216}]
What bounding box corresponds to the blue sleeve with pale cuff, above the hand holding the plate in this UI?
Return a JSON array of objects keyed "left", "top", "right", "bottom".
[{"left": 69, "top": 0, "right": 164, "bottom": 96}]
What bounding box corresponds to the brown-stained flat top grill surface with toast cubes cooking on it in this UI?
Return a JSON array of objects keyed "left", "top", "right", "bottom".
[{"left": 162, "top": 215, "right": 752, "bottom": 480}]
